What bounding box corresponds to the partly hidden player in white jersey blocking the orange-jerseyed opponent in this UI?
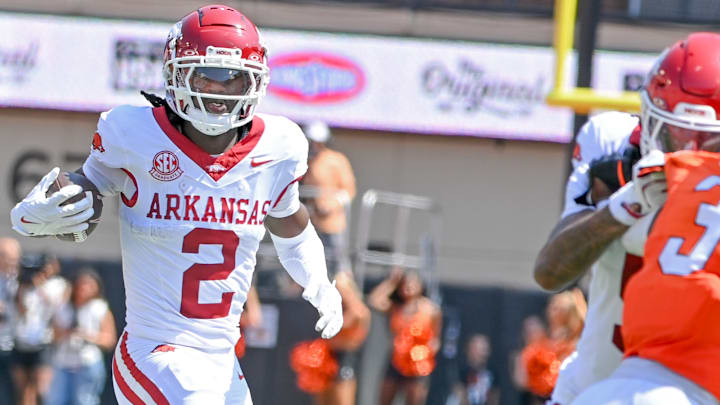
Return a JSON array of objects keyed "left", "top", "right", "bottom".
[{"left": 534, "top": 74, "right": 664, "bottom": 405}]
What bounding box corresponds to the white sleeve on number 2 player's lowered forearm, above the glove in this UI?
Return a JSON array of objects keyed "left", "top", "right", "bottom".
[{"left": 270, "top": 222, "right": 327, "bottom": 288}]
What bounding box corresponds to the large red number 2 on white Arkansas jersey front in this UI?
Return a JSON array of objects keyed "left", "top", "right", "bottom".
[{"left": 180, "top": 228, "right": 240, "bottom": 319}]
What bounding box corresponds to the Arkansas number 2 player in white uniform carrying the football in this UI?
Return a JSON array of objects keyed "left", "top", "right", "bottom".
[{"left": 11, "top": 5, "right": 343, "bottom": 405}]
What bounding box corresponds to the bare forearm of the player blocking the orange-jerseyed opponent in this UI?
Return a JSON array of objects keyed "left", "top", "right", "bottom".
[{"left": 535, "top": 208, "right": 628, "bottom": 290}]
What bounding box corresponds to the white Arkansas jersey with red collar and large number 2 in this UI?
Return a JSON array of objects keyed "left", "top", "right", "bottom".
[{"left": 83, "top": 106, "right": 308, "bottom": 349}]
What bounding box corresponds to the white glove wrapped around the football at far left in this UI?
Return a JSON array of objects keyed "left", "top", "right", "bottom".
[{"left": 10, "top": 167, "right": 94, "bottom": 236}]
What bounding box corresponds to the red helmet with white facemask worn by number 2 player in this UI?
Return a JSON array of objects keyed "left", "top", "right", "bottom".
[{"left": 163, "top": 5, "right": 270, "bottom": 136}]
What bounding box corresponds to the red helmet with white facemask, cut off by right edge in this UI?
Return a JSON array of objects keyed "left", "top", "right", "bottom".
[{"left": 640, "top": 32, "right": 720, "bottom": 155}]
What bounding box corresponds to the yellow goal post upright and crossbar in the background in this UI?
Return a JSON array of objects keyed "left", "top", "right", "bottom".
[{"left": 546, "top": 0, "right": 640, "bottom": 114}]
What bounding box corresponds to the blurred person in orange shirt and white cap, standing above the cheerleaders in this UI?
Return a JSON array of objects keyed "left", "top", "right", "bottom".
[{"left": 302, "top": 121, "right": 355, "bottom": 274}]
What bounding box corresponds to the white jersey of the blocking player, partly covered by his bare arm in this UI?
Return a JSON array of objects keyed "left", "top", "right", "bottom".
[{"left": 549, "top": 112, "right": 642, "bottom": 405}]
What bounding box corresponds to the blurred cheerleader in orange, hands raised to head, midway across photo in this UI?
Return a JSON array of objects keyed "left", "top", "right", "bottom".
[{"left": 368, "top": 267, "right": 442, "bottom": 405}]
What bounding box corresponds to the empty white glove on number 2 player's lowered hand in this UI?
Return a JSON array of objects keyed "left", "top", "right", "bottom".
[{"left": 303, "top": 281, "right": 343, "bottom": 339}]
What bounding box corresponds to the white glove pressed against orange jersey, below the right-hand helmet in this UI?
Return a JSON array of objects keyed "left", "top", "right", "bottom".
[{"left": 633, "top": 150, "right": 667, "bottom": 211}]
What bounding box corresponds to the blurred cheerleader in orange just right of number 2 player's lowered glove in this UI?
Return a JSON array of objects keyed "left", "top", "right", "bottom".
[{"left": 314, "top": 271, "right": 370, "bottom": 405}]
